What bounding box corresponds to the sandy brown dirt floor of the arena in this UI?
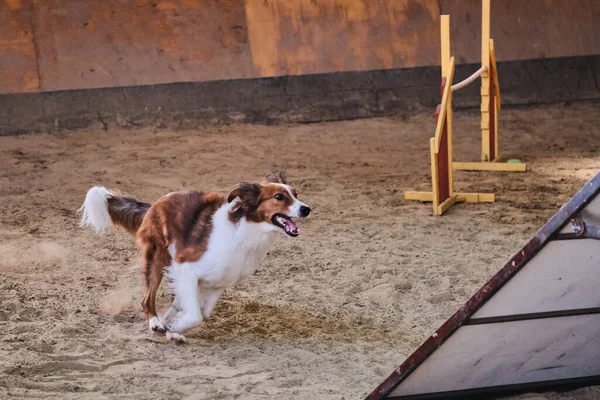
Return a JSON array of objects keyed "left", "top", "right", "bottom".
[{"left": 0, "top": 103, "right": 600, "bottom": 400}]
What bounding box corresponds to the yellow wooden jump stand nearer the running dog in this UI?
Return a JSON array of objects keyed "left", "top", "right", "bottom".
[{"left": 404, "top": 15, "right": 495, "bottom": 215}]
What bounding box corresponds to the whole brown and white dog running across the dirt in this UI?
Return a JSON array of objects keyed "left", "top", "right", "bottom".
[{"left": 81, "top": 173, "right": 310, "bottom": 341}]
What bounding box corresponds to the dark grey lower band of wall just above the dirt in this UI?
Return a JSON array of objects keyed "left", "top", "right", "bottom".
[{"left": 0, "top": 55, "right": 600, "bottom": 137}]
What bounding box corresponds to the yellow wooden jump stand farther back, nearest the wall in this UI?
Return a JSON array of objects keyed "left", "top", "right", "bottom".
[{"left": 454, "top": 0, "right": 527, "bottom": 172}]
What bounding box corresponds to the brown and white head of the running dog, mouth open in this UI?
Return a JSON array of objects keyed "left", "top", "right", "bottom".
[{"left": 227, "top": 172, "right": 311, "bottom": 237}]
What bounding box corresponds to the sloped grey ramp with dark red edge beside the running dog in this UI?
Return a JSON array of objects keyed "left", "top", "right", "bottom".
[{"left": 367, "top": 174, "right": 600, "bottom": 400}]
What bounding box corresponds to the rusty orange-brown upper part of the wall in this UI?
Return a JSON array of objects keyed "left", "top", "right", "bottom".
[{"left": 0, "top": 0, "right": 600, "bottom": 93}]
